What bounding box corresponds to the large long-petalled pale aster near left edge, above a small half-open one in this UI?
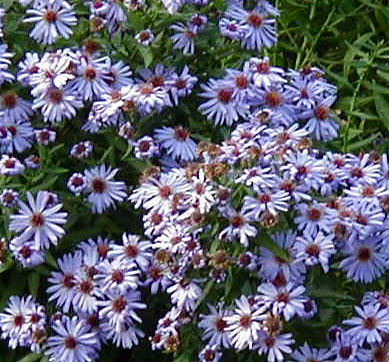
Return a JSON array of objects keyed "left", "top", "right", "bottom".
[{"left": 9, "top": 191, "right": 68, "bottom": 249}]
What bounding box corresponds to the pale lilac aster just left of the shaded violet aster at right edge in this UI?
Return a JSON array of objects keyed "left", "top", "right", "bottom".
[{"left": 294, "top": 232, "right": 336, "bottom": 273}]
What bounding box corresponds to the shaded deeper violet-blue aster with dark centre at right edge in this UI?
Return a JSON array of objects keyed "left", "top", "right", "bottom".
[{"left": 339, "top": 236, "right": 389, "bottom": 283}]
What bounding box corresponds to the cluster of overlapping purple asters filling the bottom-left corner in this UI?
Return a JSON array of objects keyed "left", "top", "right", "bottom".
[{"left": 0, "top": 234, "right": 152, "bottom": 362}]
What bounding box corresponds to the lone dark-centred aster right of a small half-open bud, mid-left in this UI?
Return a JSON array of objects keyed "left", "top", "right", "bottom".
[{"left": 85, "top": 164, "right": 126, "bottom": 214}]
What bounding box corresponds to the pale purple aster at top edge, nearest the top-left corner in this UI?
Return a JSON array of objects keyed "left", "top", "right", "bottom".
[{"left": 24, "top": 0, "right": 77, "bottom": 44}]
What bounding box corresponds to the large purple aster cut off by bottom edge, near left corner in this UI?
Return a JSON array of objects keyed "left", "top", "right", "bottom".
[{"left": 46, "top": 316, "right": 99, "bottom": 362}]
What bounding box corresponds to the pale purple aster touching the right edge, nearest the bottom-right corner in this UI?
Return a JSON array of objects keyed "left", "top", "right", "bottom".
[{"left": 343, "top": 305, "right": 389, "bottom": 346}]
